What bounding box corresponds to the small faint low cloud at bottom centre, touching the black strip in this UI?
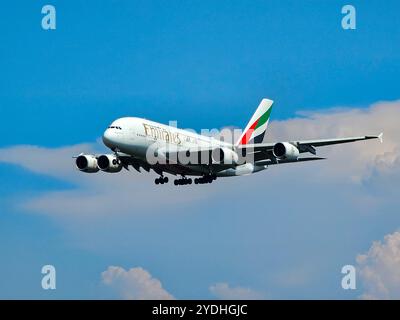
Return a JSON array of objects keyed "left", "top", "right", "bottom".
[{"left": 209, "top": 282, "right": 265, "bottom": 300}]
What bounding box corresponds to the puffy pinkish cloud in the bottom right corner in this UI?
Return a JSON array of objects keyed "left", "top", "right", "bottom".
[{"left": 357, "top": 232, "right": 400, "bottom": 299}]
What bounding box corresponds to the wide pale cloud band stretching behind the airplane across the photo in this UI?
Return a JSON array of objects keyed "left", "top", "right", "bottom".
[{"left": 0, "top": 101, "right": 400, "bottom": 219}]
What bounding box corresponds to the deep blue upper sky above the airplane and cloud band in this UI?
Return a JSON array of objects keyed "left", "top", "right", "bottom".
[{"left": 0, "top": 1, "right": 400, "bottom": 146}]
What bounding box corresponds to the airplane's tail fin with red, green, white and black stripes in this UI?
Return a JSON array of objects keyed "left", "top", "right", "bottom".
[{"left": 236, "top": 99, "right": 274, "bottom": 145}]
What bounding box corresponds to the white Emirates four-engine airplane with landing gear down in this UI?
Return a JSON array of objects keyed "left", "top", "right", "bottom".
[{"left": 74, "top": 99, "right": 383, "bottom": 185}]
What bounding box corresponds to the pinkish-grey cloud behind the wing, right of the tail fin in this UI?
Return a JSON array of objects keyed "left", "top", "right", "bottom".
[{"left": 268, "top": 101, "right": 400, "bottom": 183}]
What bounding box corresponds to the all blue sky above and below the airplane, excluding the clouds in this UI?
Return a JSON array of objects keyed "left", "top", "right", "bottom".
[{"left": 0, "top": 0, "right": 400, "bottom": 298}]
